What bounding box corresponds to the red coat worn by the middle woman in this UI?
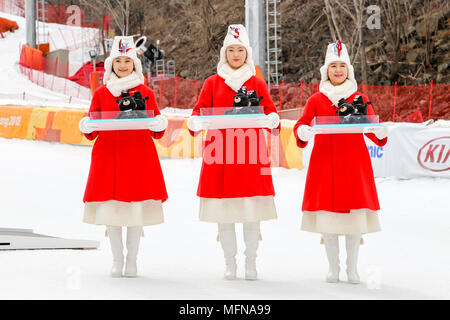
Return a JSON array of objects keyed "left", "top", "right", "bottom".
[{"left": 191, "top": 75, "right": 279, "bottom": 198}]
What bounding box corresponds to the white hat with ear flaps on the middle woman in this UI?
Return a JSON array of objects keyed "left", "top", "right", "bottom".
[{"left": 217, "top": 24, "right": 256, "bottom": 75}]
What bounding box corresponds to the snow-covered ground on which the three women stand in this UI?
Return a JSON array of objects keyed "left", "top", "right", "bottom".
[{"left": 0, "top": 138, "right": 450, "bottom": 299}]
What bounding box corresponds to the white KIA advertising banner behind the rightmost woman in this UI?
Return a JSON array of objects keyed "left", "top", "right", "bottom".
[{"left": 303, "top": 121, "right": 450, "bottom": 179}]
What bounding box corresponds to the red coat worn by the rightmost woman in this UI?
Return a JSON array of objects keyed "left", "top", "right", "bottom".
[{"left": 294, "top": 92, "right": 387, "bottom": 213}]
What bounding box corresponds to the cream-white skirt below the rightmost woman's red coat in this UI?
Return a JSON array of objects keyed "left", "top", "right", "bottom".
[{"left": 301, "top": 209, "right": 381, "bottom": 235}]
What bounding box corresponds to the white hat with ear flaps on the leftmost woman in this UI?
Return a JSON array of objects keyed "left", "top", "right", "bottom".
[{"left": 103, "top": 36, "right": 144, "bottom": 84}]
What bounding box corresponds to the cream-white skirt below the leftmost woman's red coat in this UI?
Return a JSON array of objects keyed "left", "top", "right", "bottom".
[{"left": 83, "top": 200, "right": 164, "bottom": 227}]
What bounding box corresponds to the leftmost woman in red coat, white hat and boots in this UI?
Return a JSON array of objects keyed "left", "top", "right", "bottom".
[{"left": 80, "top": 37, "right": 167, "bottom": 277}]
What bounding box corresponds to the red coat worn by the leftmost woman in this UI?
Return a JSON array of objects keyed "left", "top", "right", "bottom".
[{"left": 83, "top": 85, "right": 167, "bottom": 202}]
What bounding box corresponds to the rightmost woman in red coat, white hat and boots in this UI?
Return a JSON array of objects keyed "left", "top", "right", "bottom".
[{"left": 294, "top": 41, "right": 387, "bottom": 283}]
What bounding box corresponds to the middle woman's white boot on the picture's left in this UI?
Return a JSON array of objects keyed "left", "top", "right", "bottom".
[{"left": 219, "top": 223, "right": 237, "bottom": 280}]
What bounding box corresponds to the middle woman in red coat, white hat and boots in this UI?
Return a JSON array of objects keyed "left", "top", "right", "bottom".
[{"left": 188, "top": 25, "right": 280, "bottom": 280}]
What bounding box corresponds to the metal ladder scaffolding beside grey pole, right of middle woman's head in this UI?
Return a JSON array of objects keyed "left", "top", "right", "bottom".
[{"left": 266, "top": 0, "right": 283, "bottom": 88}]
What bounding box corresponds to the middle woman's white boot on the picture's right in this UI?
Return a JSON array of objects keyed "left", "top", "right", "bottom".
[{"left": 244, "top": 221, "right": 260, "bottom": 280}]
